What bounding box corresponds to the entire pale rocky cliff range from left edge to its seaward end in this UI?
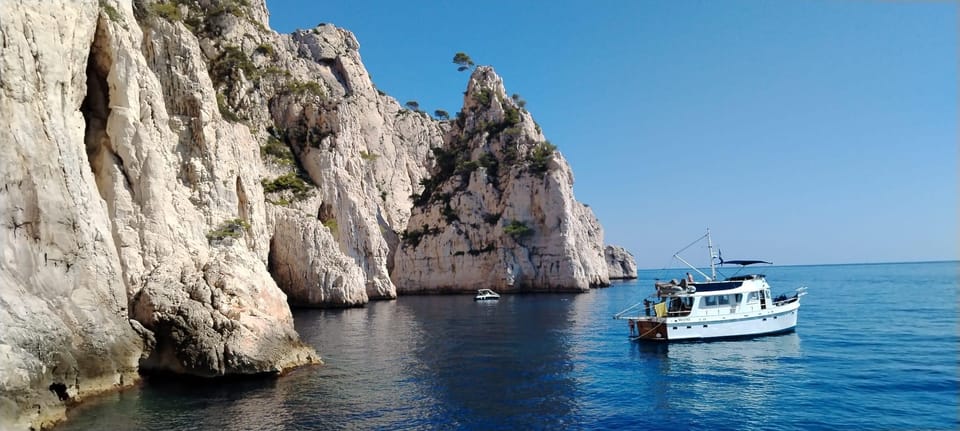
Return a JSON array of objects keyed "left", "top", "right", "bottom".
[{"left": 0, "top": 0, "right": 636, "bottom": 429}]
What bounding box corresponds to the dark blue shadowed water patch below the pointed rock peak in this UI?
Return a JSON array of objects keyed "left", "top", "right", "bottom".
[{"left": 398, "top": 294, "right": 576, "bottom": 429}]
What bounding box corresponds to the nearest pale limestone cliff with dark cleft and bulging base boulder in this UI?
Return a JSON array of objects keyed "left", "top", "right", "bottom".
[{"left": 0, "top": 0, "right": 318, "bottom": 429}]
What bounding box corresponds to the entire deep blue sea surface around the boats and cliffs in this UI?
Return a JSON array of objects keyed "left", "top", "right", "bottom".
[{"left": 58, "top": 262, "right": 960, "bottom": 430}]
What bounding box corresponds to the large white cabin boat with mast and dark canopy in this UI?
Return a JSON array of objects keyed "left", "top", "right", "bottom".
[{"left": 613, "top": 230, "right": 807, "bottom": 341}]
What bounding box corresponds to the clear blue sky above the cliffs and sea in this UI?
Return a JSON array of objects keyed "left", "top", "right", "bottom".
[{"left": 267, "top": 0, "right": 960, "bottom": 268}]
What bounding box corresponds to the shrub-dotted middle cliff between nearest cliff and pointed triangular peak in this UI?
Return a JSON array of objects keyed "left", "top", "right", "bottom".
[{"left": 152, "top": 5, "right": 443, "bottom": 307}]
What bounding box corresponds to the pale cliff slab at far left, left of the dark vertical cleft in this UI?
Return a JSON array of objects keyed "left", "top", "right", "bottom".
[{"left": 0, "top": 2, "right": 149, "bottom": 429}]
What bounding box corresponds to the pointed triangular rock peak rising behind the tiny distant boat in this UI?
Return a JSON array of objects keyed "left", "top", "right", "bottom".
[{"left": 393, "top": 66, "right": 609, "bottom": 293}]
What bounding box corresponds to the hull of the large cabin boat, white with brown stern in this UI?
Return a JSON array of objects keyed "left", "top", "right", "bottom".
[{"left": 631, "top": 304, "right": 799, "bottom": 341}]
